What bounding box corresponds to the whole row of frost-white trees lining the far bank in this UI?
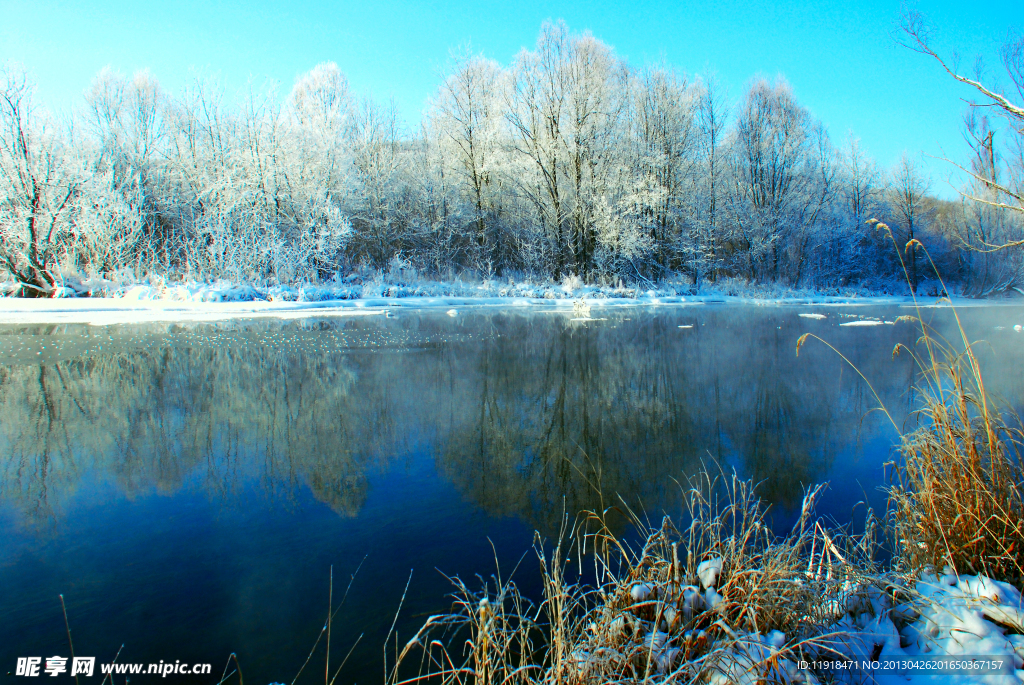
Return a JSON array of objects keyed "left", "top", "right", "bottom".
[{"left": 0, "top": 23, "right": 1024, "bottom": 295}]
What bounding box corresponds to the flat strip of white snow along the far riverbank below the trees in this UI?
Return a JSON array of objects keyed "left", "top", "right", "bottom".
[{"left": 0, "top": 274, "right": 1018, "bottom": 325}]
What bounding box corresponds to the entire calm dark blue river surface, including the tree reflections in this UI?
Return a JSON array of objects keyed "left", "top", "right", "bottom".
[{"left": 0, "top": 305, "right": 1024, "bottom": 683}]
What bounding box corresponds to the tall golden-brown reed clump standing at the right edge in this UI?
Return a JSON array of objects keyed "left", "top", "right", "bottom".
[{"left": 889, "top": 298, "right": 1024, "bottom": 587}]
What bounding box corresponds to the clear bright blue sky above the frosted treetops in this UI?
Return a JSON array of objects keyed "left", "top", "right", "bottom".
[{"left": 0, "top": 0, "right": 1024, "bottom": 197}]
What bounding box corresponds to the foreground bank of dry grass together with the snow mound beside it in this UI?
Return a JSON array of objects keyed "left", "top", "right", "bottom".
[{"left": 396, "top": 464, "right": 1024, "bottom": 685}]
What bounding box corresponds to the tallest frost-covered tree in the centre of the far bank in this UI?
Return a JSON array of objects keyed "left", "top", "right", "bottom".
[{"left": 505, "top": 24, "right": 628, "bottom": 279}]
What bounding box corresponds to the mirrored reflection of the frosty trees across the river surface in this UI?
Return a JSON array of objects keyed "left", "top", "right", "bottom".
[{"left": 0, "top": 307, "right": 974, "bottom": 530}]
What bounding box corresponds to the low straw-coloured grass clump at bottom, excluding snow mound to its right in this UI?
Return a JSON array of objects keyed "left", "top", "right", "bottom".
[{"left": 389, "top": 471, "right": 874, "bottom": 685}]
